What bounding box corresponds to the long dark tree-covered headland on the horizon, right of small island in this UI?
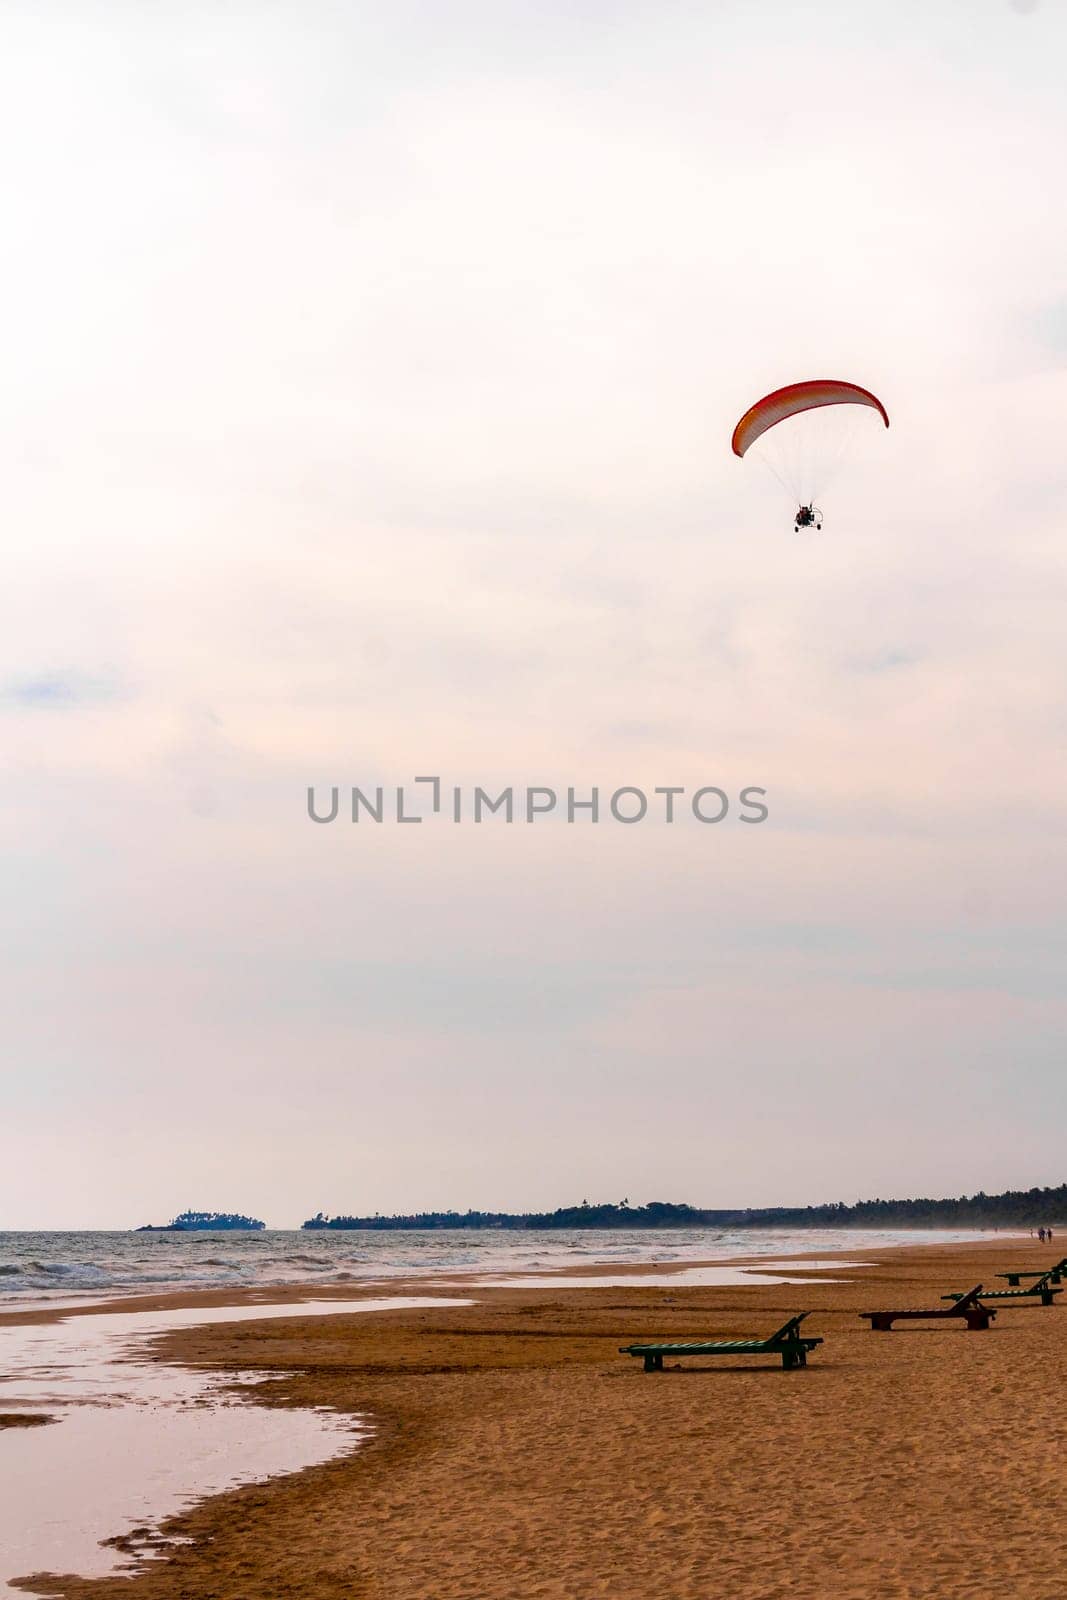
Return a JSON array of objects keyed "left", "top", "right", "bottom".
[{"left": 302, "top": 1184, "right": 1067, "bottom": 1232}]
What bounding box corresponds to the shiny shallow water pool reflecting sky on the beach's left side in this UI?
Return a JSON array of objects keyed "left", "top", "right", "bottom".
[{"left": 0, "top": 1296, "right": 469, "bottom": 1597}]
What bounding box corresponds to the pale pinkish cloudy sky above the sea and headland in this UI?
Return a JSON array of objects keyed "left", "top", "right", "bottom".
[{"left": 0, "top": 0, "right": 1067, "bottom": 1227}]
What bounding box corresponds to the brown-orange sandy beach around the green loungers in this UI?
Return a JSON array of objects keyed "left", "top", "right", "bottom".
[{"left": 8, "top": 1235, "right": 1067, "bottom": 1600}]
